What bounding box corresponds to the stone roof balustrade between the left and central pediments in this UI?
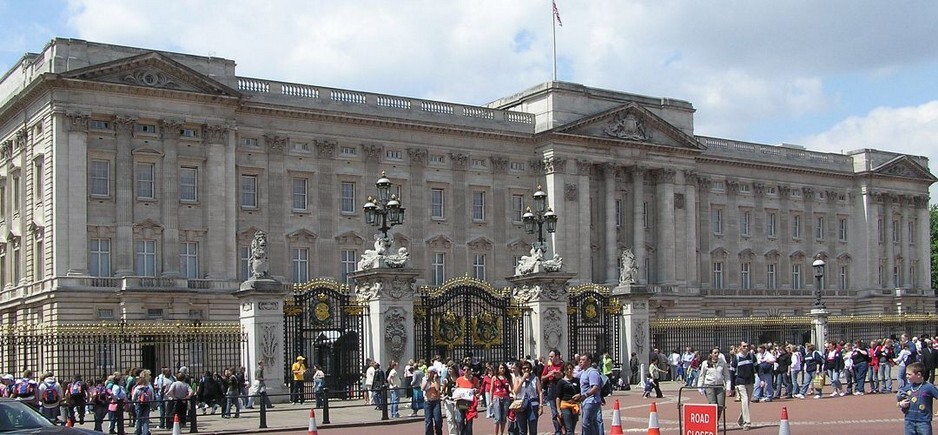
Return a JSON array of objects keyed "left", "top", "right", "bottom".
[{"left": 238, "top": 77, "right": 534, "bottom": 131}]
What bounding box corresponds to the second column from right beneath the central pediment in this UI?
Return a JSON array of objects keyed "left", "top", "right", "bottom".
[{"left": 655, "top": 169, "right": 677, "bottom": 284}]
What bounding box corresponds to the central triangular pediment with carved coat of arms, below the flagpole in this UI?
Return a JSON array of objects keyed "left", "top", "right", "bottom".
[{"left": 555, "top": 103, "right": 704, "bottom": 151}]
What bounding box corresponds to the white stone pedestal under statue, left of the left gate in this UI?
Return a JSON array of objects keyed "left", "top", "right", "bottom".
[{"left": 234, "top": 279, "right": 292, "bottom": 402}]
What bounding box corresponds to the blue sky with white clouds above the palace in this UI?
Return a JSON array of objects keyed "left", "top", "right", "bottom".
[{"left": 0, "top": 0, "right": 938, "bottom": 199}]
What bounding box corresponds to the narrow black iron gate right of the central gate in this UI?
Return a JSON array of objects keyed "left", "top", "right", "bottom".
[{"left": 567, "top": 284, "right": 622, "bottom": 360}]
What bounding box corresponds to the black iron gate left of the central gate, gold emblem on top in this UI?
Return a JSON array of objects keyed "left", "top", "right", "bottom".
[{"left": 283, "top": 279, "right": 367, "bottom": 398}]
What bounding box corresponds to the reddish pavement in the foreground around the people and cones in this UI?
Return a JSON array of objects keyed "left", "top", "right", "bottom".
[{"left": 71, "top": 382, "right": 903, "bottom": 435}]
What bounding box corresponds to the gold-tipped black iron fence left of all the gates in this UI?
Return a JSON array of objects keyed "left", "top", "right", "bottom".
[{"left": 0, "top": 321, "right": 247, "bottom": 379}]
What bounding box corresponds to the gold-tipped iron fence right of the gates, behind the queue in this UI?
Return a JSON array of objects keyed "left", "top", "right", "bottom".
[{"left": 649, "top": 314, "right": 938, "bottom": 351}]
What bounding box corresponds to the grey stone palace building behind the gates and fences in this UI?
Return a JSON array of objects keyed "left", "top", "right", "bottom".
[{"left": 0, "top": 39, "right": 936, "bottom": 374}]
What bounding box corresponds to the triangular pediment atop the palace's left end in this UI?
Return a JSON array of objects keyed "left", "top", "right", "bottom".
[{"left": 62, "top": 52, "right": 239, "bottom": 97}]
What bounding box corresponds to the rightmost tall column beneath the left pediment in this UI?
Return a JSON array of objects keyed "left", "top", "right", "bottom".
[{"left": 199, "top": 125, "right": 227, "bottom": 279}]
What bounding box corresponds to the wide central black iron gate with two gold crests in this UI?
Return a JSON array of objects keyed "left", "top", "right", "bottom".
[{"left": 414, "top": 277, "right": 525, "bottom": 363}]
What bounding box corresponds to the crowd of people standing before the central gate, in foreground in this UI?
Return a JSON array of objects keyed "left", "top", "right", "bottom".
[{"left": 362, "top": 350, "right": 615, "bottom": 435}]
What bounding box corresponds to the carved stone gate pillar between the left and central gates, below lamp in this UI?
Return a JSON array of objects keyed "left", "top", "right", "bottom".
[{"left": 349, "top": 268, "right": 421, "bottom": 367}]
